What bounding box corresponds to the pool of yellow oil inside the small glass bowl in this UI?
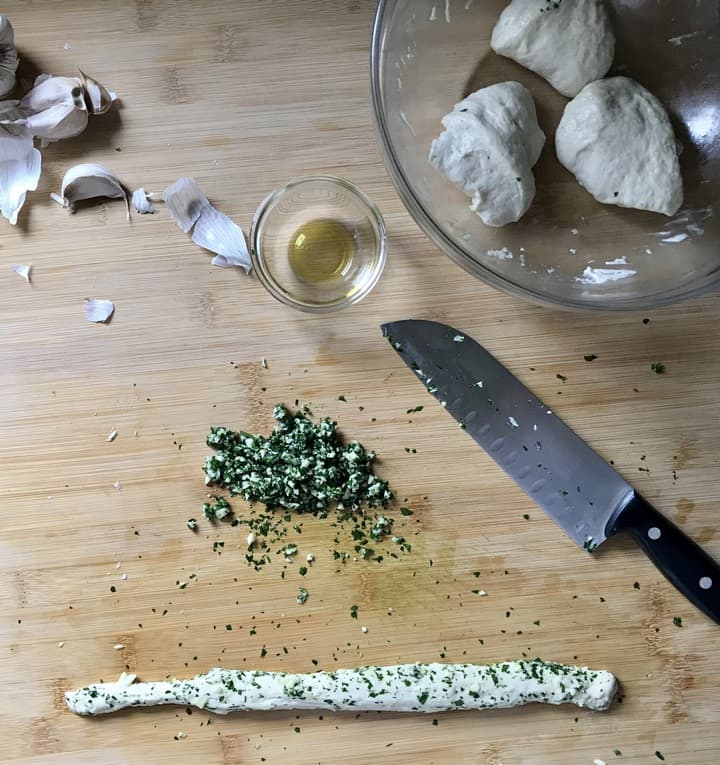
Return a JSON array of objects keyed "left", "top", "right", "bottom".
[{"left": 288, "top": 218, "right": 356, "bottom": 284}]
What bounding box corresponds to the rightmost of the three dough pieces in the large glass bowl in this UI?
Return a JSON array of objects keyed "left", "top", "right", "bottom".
[{"left": 555, "top": 77, "right": 683, "bottom": 215}]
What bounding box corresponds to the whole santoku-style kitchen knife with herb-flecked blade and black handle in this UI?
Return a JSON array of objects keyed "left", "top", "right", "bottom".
[{"left": 382, "top": 319, "right": 720, "bottom": 623}]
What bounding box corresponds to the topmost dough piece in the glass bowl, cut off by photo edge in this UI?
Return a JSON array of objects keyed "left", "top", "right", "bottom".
[{"left": 490, "top": 0, "right": 615, "bottom": 98}]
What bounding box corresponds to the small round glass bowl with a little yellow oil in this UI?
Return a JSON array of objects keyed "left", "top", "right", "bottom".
[{"left": 250, "top": 175, "right": 387, "bottom": 313}]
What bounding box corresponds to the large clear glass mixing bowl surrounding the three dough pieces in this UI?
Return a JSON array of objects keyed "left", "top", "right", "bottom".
[{"left": 371, "top": 0, "right": 720, "bottom": 310}]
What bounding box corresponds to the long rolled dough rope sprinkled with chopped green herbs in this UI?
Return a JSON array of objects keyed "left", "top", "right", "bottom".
[{"left": 65, "top": 659, "right": 617, "bottom": 715}]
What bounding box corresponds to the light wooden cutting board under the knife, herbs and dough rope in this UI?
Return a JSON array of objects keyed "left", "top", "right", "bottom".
[{"left": 0, "top": 0, "right": 720, "bottom": 765}]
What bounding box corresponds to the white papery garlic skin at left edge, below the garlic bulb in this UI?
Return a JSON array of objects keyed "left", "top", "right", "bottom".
[{"left": 0, "top": 127, "right": 41, "bottom": 226}]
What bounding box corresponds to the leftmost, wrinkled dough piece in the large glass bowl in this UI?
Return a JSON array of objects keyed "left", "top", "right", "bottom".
[{"left": 429, "top": 82, "right": 545, "bottom": 226}]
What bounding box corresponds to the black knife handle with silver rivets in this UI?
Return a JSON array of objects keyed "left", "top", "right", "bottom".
[{"left": 612, "top": 494, "right": 720, "bottom": 623}]
